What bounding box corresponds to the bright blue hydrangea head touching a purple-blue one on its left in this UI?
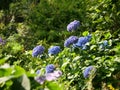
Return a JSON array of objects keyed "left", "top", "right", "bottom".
[{"left": 73, "top": 35, "right": 91, "bottom": 49}]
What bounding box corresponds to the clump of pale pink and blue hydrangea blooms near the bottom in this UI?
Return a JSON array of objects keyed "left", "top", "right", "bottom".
[{"left": 35, "top": 64, "right": 62, "bottom": 84}]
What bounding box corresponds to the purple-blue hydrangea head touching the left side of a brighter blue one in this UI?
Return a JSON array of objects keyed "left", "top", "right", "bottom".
[{"left": 64, "top": 36, "right": 78, "bottom": 47}]
